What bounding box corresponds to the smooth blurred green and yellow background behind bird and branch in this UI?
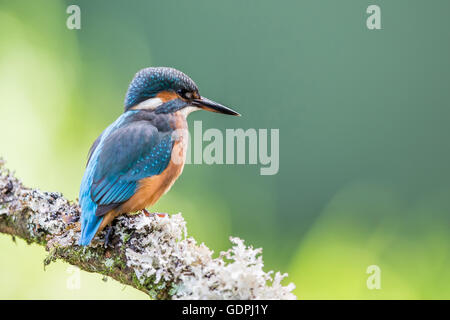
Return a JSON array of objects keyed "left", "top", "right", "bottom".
[{"left": 0, "top": 0, "right": 450, "bottom": 299}]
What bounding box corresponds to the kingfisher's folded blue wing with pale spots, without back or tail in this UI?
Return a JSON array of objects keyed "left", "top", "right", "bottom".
[{"left": 91, "top": 121, "right": 173, "bottom": 211}]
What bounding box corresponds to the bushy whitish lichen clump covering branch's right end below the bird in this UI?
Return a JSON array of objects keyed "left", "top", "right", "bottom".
[{"left": 122, "top": 214, "right": 296, "bottom": 300}]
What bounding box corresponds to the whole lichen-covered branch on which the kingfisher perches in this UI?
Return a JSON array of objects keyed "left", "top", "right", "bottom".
[{"left": 0, "top": 159, "right": 295, "bottom": 299}]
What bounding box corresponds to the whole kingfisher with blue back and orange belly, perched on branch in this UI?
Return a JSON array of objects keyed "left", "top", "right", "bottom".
[{"left": 79, "top": 67, "right": 240, "bottom": 246}]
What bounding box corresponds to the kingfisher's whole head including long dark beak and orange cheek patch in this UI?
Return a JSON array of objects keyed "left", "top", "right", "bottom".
[{"left": 125, "top": 67, "right": 240, "bottom": 116}]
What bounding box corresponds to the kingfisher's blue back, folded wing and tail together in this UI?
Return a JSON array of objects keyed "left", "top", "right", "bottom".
[{"left": 80, "top": 121, "right": 173, "bottom": 244}]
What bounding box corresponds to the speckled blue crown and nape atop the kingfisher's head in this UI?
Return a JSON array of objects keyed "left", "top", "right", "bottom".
[{"left": 125, "top": 67, "right": 198, "bottom": 111}]
